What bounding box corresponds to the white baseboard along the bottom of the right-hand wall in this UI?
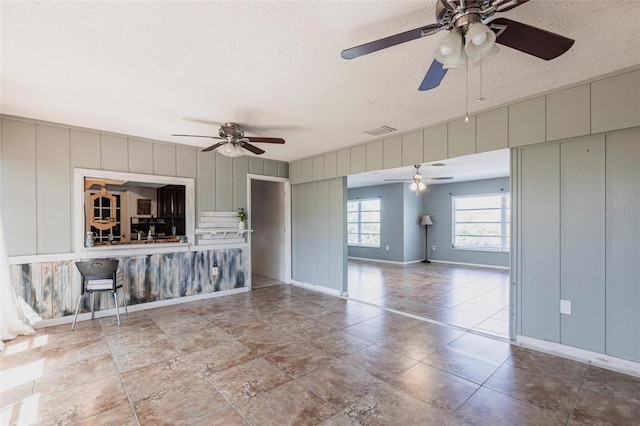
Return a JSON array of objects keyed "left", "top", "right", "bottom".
[{"left": 516, "top": 334, "right": 640, "bottom": 377}]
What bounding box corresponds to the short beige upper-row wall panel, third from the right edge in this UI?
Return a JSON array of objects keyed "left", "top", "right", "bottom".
[{"left": 509, "top": 96, "right": 546, "bottom": 148}]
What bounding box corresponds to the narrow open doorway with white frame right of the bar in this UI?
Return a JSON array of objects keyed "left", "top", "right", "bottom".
[{"left": 247, "top": 175, "right": 291, "bottom": 289}]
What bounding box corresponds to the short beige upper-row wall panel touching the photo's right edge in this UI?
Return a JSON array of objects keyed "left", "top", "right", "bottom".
[{"left": 591, "top": 70, "right": 640, "bottom": 133}]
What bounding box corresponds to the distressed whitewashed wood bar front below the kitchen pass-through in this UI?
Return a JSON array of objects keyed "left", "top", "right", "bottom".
[{"left": 11, "top": 245, "right": 250, "bottom": 326}]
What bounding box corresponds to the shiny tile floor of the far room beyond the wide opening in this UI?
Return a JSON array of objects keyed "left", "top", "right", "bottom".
[{"left": 348, "top": 259, "right": 509, "bottom": 338}]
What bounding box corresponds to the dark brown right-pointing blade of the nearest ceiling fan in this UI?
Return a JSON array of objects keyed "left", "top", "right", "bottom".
[{"left": 489, "top": 18, "right": 575, "bottom": 61}]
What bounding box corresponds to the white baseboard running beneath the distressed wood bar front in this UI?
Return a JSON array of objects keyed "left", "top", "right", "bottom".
[{"left": 32, "top": 287, "right": 250, "bottom": 328}]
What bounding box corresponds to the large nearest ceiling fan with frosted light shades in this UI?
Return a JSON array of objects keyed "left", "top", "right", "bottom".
[{"left": 342, "top": 0, "right": 575, "bottom": 91}]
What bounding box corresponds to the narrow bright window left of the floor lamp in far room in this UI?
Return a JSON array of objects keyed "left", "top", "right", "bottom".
[{"left": 347, "top": 198, "right": 380, "bottom": 247}]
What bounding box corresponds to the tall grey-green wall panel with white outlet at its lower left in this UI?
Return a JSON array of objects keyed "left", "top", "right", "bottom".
[{"left": 560, "top": 135, "right": 605, "bottom": 353}]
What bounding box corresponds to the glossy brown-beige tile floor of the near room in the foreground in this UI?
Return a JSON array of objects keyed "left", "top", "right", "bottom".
[{"left": 0, "top": 278, "right": 640, "bottom": 426}]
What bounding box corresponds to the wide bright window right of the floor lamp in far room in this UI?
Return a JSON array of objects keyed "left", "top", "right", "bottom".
[{"left": 452, "top": 194, "right": 511, "bottom": 251}]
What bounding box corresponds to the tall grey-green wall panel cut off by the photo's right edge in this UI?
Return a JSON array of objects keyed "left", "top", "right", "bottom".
[{"left": 605, "top": 128, "right": 640, "bottom": 361}]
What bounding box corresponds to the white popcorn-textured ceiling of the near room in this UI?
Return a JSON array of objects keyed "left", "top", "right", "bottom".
[{"left": 0, "top": 0, "right": 640, "bottom": 161}]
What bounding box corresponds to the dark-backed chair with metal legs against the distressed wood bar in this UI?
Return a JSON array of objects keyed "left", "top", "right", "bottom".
[{"left": 71, "top": 259, "right": 129, "bottom": 331}]
